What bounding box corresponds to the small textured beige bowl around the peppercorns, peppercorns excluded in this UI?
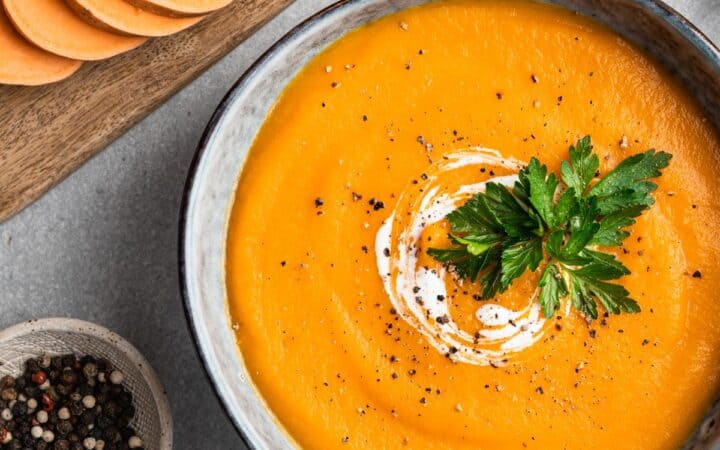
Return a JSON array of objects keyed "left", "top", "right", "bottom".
[{"left": 0, "top": 318, "right": 172, "bottom": 450}]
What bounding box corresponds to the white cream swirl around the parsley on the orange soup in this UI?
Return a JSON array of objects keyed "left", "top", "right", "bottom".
[{"left": 375, "top": 147, "right": 545, "bottom": 366}]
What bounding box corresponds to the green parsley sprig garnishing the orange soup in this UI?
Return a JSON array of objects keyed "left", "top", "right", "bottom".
[{"left": 428, "top": 136, "right": 672, "bottom": 319}]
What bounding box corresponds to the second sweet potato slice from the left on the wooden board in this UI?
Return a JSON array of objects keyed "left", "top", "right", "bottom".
[{"left": 2, "top": 0, "right": 146, "bottom": 61}]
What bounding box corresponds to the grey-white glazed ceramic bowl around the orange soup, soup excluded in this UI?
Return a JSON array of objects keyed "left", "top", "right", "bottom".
[{"left": 180, "top": 0, "right": 720, "bottom": 449}]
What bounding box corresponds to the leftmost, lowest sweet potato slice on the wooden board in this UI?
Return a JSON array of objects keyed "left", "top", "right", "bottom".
[{"left": 0, "top": 8, "right": 82, "bottom": 86}]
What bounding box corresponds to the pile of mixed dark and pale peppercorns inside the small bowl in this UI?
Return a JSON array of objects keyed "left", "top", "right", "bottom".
[{"left": 0, "top": 355, "right": 143, "bottom": 450}]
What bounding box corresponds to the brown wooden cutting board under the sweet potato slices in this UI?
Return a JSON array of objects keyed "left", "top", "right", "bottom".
[{"left": 0, "top": 0, "right": 292, "bottom": 221}]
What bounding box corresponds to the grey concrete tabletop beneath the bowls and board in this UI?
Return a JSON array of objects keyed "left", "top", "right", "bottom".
[{"left": 0, "top": 0, "right": 720, "bottom": 450}]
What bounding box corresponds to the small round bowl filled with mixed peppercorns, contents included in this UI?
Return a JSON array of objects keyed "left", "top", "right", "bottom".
[{"left": 0, "top": 318, "right": 172, "bottom": 450}]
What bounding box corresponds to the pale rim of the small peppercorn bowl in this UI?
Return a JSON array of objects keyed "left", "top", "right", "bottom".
[{"left": 0, "top": 317, "right": 173, "bottom": 450}]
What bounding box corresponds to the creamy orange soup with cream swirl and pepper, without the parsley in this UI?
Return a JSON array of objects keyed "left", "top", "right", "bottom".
[{"left": 226, "top": 0, "right": 720, "bottom": 449}]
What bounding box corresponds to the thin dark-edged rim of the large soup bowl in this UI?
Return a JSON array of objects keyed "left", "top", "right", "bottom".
[{"left": 178, "top": 0, "right": 720, "bottom": 448}]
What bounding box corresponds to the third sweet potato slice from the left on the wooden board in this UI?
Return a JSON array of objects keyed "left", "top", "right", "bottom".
[{"left": 65, "top": 0, "right": 204, "bottom": 37}]
